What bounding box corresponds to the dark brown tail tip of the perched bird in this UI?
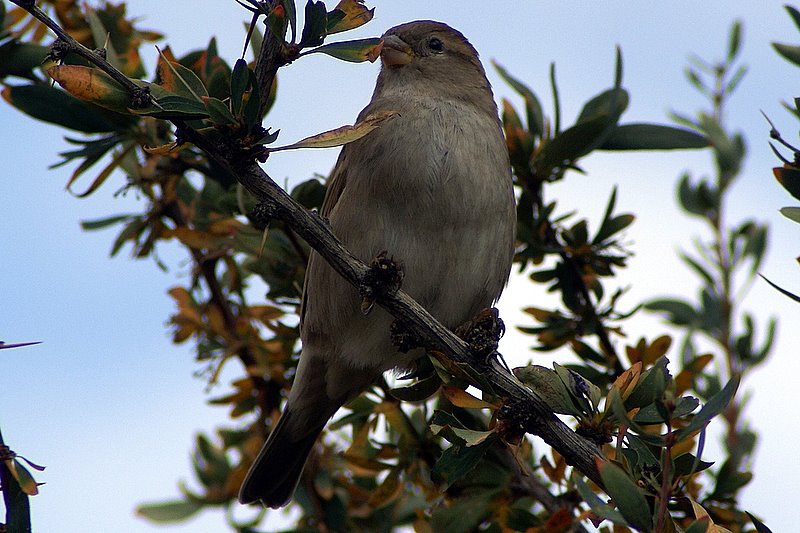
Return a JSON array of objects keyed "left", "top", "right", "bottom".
[{"left": 239, "top": 409, "right": 327, "bottom": 509}]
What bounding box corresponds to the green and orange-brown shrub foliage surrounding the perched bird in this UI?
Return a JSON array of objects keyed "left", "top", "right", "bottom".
[{"left": 0, "top": 0, "right": 774, "bottom": 531}]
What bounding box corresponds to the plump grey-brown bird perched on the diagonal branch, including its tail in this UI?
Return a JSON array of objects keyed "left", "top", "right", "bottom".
[{"left": 239, "top": 20, "right": 516, "bottom": 509}]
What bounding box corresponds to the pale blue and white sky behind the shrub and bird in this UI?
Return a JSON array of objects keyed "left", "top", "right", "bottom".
[{"left": 0, "top": 0, "right": 800, "bottom": 533}]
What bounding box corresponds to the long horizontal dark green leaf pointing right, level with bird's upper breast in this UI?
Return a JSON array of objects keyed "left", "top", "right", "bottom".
[{"left": 598, "top": 124, "right": 710, "bottom": 150}]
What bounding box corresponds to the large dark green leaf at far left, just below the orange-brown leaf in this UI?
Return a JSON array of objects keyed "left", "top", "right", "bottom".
[{"left": 2, "top": 85, "right": 117, "bottom": 133}]
